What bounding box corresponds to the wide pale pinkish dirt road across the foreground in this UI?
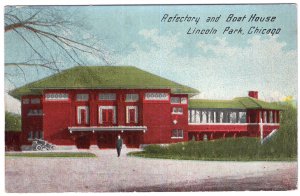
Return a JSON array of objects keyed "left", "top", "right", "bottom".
[{"left": 5, "top": 150, "right": 297, "bottom": 192}]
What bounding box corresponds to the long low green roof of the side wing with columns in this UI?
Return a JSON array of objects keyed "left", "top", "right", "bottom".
[{"left": 189, "top": 97, "right": 283, "bottom": 110}]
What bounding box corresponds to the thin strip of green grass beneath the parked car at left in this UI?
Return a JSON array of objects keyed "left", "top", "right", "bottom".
[{"left": 5, "top": 152, "right": 96, "bottom": 158}]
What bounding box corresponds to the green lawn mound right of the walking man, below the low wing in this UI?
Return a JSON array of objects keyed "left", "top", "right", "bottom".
[{"left": 129, "top": 138, "right": 297, "bottom": 161}]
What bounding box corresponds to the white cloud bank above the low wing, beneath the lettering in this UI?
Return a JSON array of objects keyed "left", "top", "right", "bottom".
[{"left": 118, "top": 29, "right": 297, "bottom": 100}]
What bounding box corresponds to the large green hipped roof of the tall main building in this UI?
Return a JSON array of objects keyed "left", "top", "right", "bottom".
[{"left": 10, "top": 66, "right": 199, "bottom": 99}]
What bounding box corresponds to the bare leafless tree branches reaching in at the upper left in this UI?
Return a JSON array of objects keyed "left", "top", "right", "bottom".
[{"left": 4, "top": 6, "right": 110, "bottom": 81}]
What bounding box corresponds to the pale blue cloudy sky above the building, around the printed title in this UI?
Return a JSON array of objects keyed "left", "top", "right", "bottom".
[{"left": 5, "top": 4, "right": 297, "bottom": 100}]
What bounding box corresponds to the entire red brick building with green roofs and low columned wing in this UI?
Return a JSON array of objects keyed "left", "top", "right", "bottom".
[{"left": 10, "top": 66, "right": 280, "bottom": 148}]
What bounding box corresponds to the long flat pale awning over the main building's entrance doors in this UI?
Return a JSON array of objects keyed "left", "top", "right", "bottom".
[{"left": 68, "top": 126, "right": 147, "bottom": 132}]
